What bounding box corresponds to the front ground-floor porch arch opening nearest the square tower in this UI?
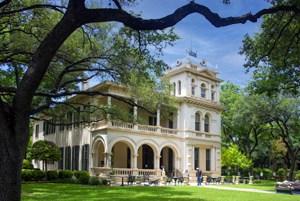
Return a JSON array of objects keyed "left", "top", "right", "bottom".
[{"left": 159, "top": 147, "right": 175, "bottom": 177}]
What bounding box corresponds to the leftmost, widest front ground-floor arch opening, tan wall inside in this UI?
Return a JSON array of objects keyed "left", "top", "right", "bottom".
[{"left": 112, "top": 142, "right": 132, "bottom": 168}]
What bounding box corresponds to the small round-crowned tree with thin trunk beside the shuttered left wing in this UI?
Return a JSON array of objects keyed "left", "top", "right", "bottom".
[{"left": 31, "top": 140, "right": 61, "bottom": 181}]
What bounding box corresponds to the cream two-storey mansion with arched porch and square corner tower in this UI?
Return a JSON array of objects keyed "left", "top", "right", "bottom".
[{"left": 33, "top": 54, "right": 222, "bottom": 181}]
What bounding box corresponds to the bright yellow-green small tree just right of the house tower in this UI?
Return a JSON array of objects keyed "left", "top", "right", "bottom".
[{"left": 221, "top": 144, "right": 252, "bottom": 173}]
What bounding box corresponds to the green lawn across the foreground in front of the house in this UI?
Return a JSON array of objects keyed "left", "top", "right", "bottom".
[{"left": 22, "top": 183, "right": 300, "bottom": 201}]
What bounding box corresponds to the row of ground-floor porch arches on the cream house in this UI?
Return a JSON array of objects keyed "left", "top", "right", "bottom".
[{"left": 93, "top": 140, "right": 179, "bottom": 175}]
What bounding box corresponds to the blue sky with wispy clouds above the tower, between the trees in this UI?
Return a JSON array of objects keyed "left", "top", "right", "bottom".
[{"left": 125, "top": 0, "right": 270, "bottom": 87}]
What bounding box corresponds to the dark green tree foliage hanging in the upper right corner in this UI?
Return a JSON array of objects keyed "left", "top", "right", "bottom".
[{"left": 240, "top": 0, "right": 300, "bottom": 94}]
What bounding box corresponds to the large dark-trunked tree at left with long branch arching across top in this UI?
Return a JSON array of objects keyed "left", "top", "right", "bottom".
[{"left": 0, "top": 0, "right": 300, "bottom": 200}]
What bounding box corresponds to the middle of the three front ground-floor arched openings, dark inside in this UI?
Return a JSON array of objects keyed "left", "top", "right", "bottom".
[{"left": 138, "top": 144, "right": 154, "bottom": 169}]
